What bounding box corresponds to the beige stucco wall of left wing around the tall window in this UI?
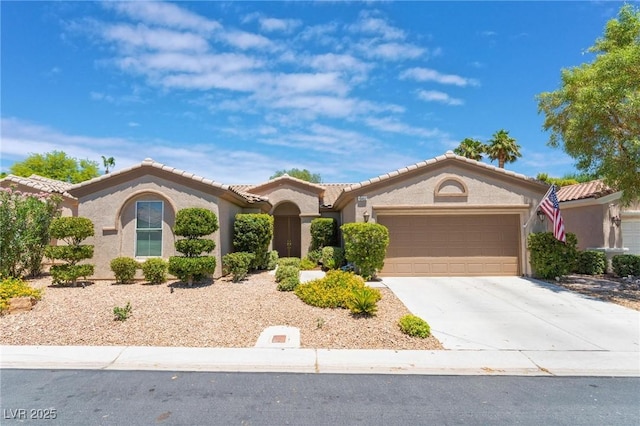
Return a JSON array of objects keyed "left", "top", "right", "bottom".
[{"left": 78, "top": 175, "right": 235, "bottom": 279}]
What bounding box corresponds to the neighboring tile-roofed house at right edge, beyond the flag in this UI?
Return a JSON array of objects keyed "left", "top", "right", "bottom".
[{"left": 558, "top": 180, "right": 640, "bottom": 259}]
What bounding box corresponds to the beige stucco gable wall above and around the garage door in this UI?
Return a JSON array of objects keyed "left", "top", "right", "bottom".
[{"left": 342, "top": 164, "right": 545, "bottom": 275}]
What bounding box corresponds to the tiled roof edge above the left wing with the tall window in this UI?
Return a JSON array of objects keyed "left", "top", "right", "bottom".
[{"left": 69, "top": 158, "right": 268, "bottom": 204}]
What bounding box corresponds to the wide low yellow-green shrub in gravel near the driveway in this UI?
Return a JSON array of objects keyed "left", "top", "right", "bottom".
[{"left": 295, "top": 270, "right": 365, "bottom": 308}]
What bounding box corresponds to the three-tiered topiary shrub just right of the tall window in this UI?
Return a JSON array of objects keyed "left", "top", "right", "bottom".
[{"left": 169, "top": 207, "right": 218, "bottom": 285}]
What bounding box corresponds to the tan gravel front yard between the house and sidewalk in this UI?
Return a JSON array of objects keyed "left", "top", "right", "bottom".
[{"left": 0, "top": 272, "right": 442, "bottom": 350}]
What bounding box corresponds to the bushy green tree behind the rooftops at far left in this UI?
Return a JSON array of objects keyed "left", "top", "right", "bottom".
[{"left": 9, "top": 151, "right": 100, "bottom": 183}]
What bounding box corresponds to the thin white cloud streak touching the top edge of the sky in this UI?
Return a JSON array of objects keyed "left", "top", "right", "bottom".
[{"left": 102, "top": 1, "right": 221, "bottom": 33}]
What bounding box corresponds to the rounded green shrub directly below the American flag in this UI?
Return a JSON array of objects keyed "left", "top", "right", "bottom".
[{"left": 527, "top": 232, "right": 578, "bottom": 279}]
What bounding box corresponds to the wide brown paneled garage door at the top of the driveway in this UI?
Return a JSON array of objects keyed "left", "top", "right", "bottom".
[{"left": 378, "top": 214, "right": 519, "bottom": 276}]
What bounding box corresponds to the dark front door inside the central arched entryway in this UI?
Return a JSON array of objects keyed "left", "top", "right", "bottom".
[{"left": 273, "top": 202, "right": 301, "bottom": 257}]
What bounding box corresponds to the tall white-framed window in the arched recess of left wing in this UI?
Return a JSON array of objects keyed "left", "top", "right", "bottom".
[{"left": 136, "top": 201, "right": 163, "bottom": 257}]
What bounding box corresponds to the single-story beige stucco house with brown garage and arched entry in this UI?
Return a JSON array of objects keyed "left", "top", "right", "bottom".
[{"left": 0, "top": 151, "right": 548, "bottom": 279}]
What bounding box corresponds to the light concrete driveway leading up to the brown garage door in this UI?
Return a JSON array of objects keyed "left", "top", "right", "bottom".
[{"left": 383, "top": 277, "right": 640, "bottom": 352}]
